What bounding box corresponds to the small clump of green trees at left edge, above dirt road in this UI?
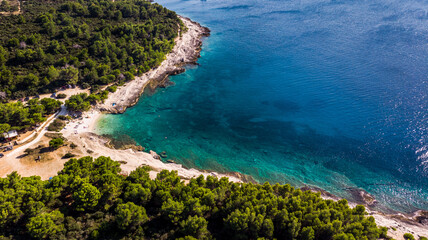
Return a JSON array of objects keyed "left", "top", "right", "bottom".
[{"left": 0, "top": 98, "right": 61, "bottom": 133}]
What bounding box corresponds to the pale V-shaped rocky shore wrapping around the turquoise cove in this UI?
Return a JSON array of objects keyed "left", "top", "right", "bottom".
[{"left": 61, "top": 16, "right": 242, "bottom": 182}]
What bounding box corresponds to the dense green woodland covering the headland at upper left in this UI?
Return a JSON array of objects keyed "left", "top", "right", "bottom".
[{"left": 0, "top": 0, "right": 183, "bottom": 99}]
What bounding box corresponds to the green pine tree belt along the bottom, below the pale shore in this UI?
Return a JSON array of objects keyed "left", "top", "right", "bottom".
[{"left": 0, "top": 157, "right": 392, "bottom": 239}]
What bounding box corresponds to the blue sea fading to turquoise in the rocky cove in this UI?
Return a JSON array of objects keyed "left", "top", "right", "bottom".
[{"left": 98, "top": 0, "right": 428, "bottom": 212}]
